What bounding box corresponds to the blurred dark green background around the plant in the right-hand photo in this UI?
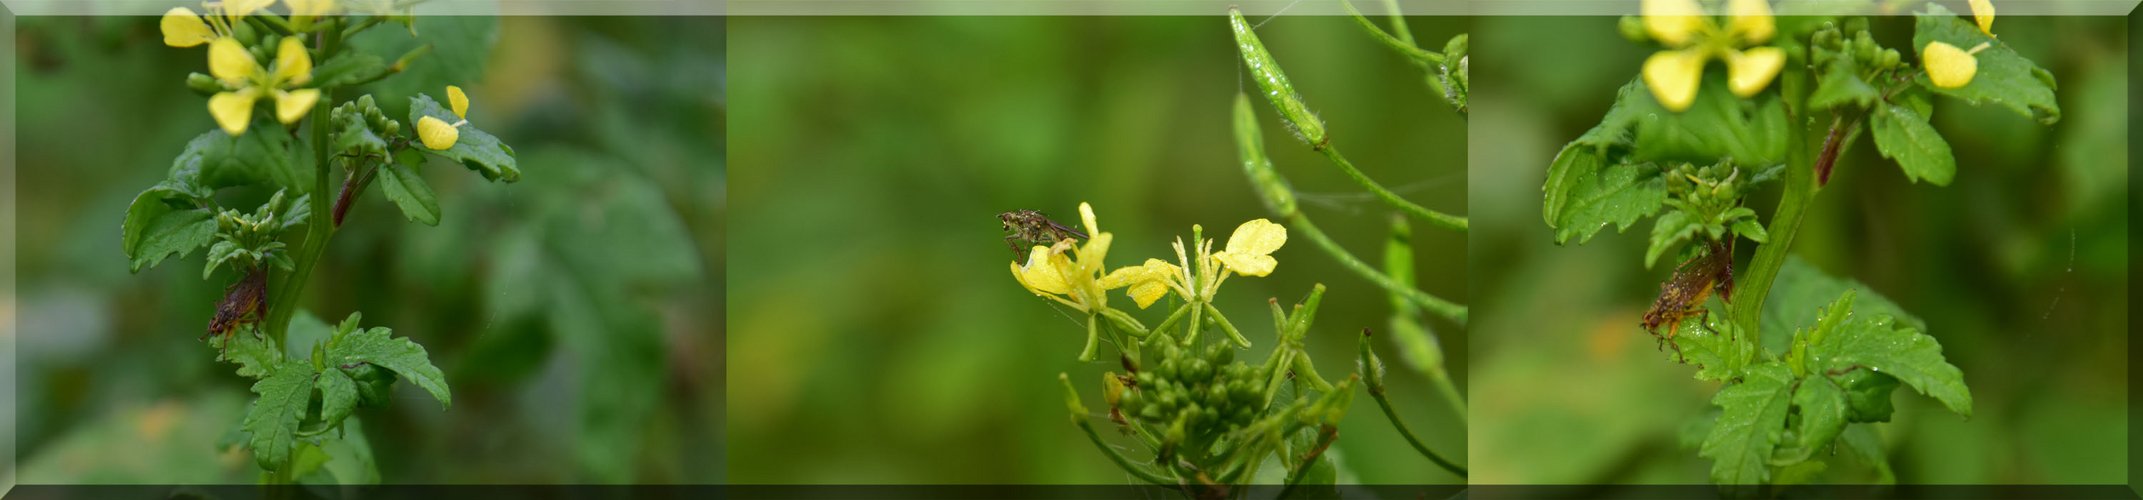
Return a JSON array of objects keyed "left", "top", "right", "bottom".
[{"left": 1468, "top": 17, "right": 2128, "bottom": 483}]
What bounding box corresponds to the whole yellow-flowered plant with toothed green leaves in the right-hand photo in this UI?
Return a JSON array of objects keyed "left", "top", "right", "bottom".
[{"left": 1541, "top": 0, "right": 2059, "bottom": 494}]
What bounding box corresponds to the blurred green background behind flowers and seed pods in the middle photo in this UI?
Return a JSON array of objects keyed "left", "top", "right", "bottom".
[{"left": 726, "top": 13, "right": 1466, "bottom": 485}]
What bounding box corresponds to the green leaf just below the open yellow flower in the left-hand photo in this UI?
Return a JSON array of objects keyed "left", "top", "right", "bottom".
[{"left": 171, "top": 129, "right": 313, "bottom": 193}]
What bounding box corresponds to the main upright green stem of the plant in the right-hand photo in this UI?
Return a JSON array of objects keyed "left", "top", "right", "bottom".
[{"left": 1732, "top": 50, "right": 1837, "bottom": 343}]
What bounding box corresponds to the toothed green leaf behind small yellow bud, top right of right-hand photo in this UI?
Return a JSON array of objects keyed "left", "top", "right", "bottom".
[{"left": 1912, "top": 2, "right": 2062, "bottom": 124}]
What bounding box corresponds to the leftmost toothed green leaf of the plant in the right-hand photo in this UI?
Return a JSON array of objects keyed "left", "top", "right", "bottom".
[{"left": 1543, "top": 148, "right": 1667, "bottom": 245}]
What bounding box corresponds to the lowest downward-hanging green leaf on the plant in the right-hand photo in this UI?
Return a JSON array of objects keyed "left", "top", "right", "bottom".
[{"left": 1697, "top": 361, "right": 1794, "bottom": 485}]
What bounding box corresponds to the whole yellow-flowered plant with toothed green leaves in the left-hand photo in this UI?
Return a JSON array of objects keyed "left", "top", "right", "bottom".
[{"left": 120, "top": 0, "right": 521, "bottom": 483}]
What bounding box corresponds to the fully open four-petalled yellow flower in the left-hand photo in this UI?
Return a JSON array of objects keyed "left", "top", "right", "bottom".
[{"left": 208, "top": 36, "right": 319, "bottom": 135}]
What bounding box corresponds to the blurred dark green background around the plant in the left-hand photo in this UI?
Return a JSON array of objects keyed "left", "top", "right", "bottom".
[{"left": 0, "top": 17, "right": 726, "bottom": 483}]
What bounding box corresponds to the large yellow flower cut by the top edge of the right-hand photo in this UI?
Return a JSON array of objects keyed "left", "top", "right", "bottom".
[{"left": 1642, "top": 0, "right": 1785, "bottom": 112}]
